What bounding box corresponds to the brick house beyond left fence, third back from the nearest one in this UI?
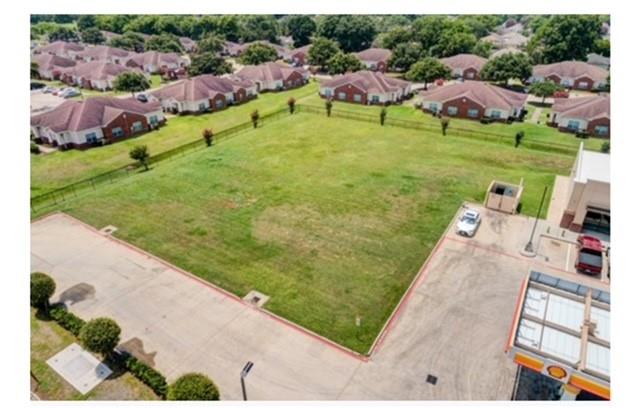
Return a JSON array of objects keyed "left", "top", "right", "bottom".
[{"left": 234, "top": 62, "right": 309, "bottom": 92}]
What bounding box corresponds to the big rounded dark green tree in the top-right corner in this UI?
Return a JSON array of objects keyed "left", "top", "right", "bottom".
[{"left": 527, "top": 15, "right": 601, "bottom": 64}]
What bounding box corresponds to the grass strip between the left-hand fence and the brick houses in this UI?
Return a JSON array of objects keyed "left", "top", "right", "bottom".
[{"left": 31, "top": 83, "right": 317, "bottom": 196}]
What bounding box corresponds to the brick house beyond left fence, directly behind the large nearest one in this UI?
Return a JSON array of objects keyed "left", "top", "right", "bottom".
[{"left": 151, "top": 74, "right": 257, "bottom": 113}]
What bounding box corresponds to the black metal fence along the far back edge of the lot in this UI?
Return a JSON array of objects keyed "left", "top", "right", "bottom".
[{"left": 297, "top": 104, "right": 578, "bottom": 154}]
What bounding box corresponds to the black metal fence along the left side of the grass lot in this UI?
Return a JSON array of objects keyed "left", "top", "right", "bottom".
[{"left": 31, "top": 108, "right": 289, "bottom": 212}]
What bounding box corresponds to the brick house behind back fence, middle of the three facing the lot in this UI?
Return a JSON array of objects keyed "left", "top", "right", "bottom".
[{"left": 420, "top": 81, "right": 527, "bottom": 121}]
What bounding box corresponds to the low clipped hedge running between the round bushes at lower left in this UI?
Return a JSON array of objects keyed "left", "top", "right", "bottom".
[{"left": 49, "top": 304, "right": 167, "bottom": 398}]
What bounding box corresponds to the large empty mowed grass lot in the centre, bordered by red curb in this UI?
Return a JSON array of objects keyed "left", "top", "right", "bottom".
[{"left": 51, "top": 113, "right": 573, "bottom": 352}]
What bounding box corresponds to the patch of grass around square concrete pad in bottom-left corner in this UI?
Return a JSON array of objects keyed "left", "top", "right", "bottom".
[{"left": 31, "top": 309, "right": 158, "bottom": 400}]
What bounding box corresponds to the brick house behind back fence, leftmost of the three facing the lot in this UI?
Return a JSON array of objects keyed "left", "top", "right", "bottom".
[{"left": 320, "top": 71, "right": 411, "bottom": 105}]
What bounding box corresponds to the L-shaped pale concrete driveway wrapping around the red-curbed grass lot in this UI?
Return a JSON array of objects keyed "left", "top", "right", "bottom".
[{"left": 31, "top": 209, "right": 559, "bottom": 400}]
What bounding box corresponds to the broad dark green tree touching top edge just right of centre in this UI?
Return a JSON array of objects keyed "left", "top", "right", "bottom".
[{"left": 318, "top": 15, "right": 376, "bottom": 52}]
